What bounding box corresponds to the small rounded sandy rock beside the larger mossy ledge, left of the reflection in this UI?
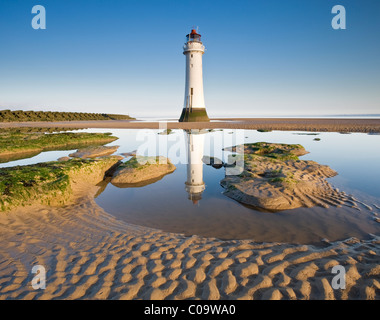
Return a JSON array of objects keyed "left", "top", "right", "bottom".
[{"left": 111, "top": 156, "right": 176, "bottom": 184}]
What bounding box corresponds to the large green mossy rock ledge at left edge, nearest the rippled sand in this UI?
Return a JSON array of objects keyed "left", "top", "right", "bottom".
[{"left": 0, "top": 156, "right": 120, "bottom": 211}]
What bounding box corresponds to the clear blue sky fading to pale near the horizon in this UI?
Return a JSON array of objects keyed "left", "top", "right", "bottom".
[{"left": 0, "top": 0, "right": 380, "bottom": 117}]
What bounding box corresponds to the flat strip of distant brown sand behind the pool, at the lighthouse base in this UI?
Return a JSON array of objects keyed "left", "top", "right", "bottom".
[{"left": 0, "top": 118, "right": 380, "bottom": 133}]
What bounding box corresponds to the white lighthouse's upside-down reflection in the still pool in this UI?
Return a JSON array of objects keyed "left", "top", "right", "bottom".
[{"left": 185, "top": 129, "right": 206, "bottom": 204}]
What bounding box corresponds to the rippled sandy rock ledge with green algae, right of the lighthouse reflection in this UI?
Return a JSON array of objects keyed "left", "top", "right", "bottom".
[{"left": 221, "top": 142, "right": 355, "bottom": 211}]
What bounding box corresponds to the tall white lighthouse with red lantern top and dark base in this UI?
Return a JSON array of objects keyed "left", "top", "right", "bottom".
[{"left": 179, "top": 29, "right": 210, "bottom": 122}]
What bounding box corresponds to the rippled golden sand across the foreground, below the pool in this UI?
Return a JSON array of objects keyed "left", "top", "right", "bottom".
[{"left": 0, "top": 184, "right": 380, "bottom": 299}]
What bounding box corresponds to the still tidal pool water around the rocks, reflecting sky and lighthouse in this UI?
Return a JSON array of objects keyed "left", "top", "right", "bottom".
[{"left": 0, "top": 129, "right": 380, "bottom": 244}]
